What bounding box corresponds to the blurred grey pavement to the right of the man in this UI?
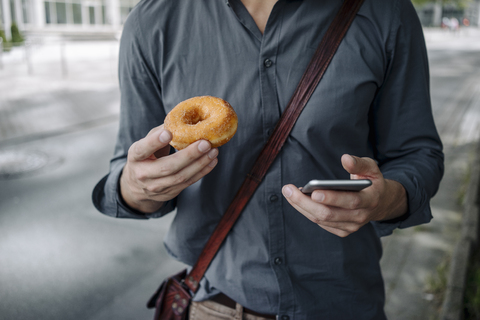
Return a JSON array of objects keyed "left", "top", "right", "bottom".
[{"left": 381, "top": 30, "right": 480, "bottom": 320}]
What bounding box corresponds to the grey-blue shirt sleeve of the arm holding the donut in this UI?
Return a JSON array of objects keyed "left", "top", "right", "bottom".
[{"left": 92, "top": 9, "right": 176, "bottom": 219}]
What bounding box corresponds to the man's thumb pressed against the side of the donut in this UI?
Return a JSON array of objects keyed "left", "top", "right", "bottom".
[{"left": 129, "top": 126, "right": 172, "bottom": 161}]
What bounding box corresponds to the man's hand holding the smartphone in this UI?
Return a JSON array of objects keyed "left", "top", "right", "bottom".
[{"left": 282, "top": 155, "right": 408, "bottom": 237}]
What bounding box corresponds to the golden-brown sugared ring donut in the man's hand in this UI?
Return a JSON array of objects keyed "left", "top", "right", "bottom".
[{"left": 164, "top": 96, "right": 238, "bottom": 150}]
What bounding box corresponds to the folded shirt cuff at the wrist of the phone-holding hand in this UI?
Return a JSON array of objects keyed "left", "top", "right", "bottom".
[{"left": 372, "top": 172, "right": 432, "bottom": 237}]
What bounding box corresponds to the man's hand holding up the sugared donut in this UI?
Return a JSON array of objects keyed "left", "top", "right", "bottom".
[{"left": 120, "top": 125, "right": 218, "bottom": 213}]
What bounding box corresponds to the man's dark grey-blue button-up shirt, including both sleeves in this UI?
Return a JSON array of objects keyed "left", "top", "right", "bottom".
[{"left": 93, "top": 0, "right": 443, "bottom": 319}]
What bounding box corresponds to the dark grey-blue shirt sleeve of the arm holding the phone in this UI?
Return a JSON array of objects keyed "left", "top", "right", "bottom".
[{"left": 370, "top": 0, "right": 444, "bottom": 236}]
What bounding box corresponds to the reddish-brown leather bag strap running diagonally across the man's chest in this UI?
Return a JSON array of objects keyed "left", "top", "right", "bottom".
[{"left": 185, "top": 0, "right": 363, "bottom": 292}]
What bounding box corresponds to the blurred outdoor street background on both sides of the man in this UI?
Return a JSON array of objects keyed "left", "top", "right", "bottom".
[{"left": 0, "top": 0, "right": 480, "bottom": 320}]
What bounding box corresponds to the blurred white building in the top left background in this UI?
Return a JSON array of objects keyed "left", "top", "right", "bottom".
[{"left": 0, "top": 0, "right": 139, "bottom": 39}]
